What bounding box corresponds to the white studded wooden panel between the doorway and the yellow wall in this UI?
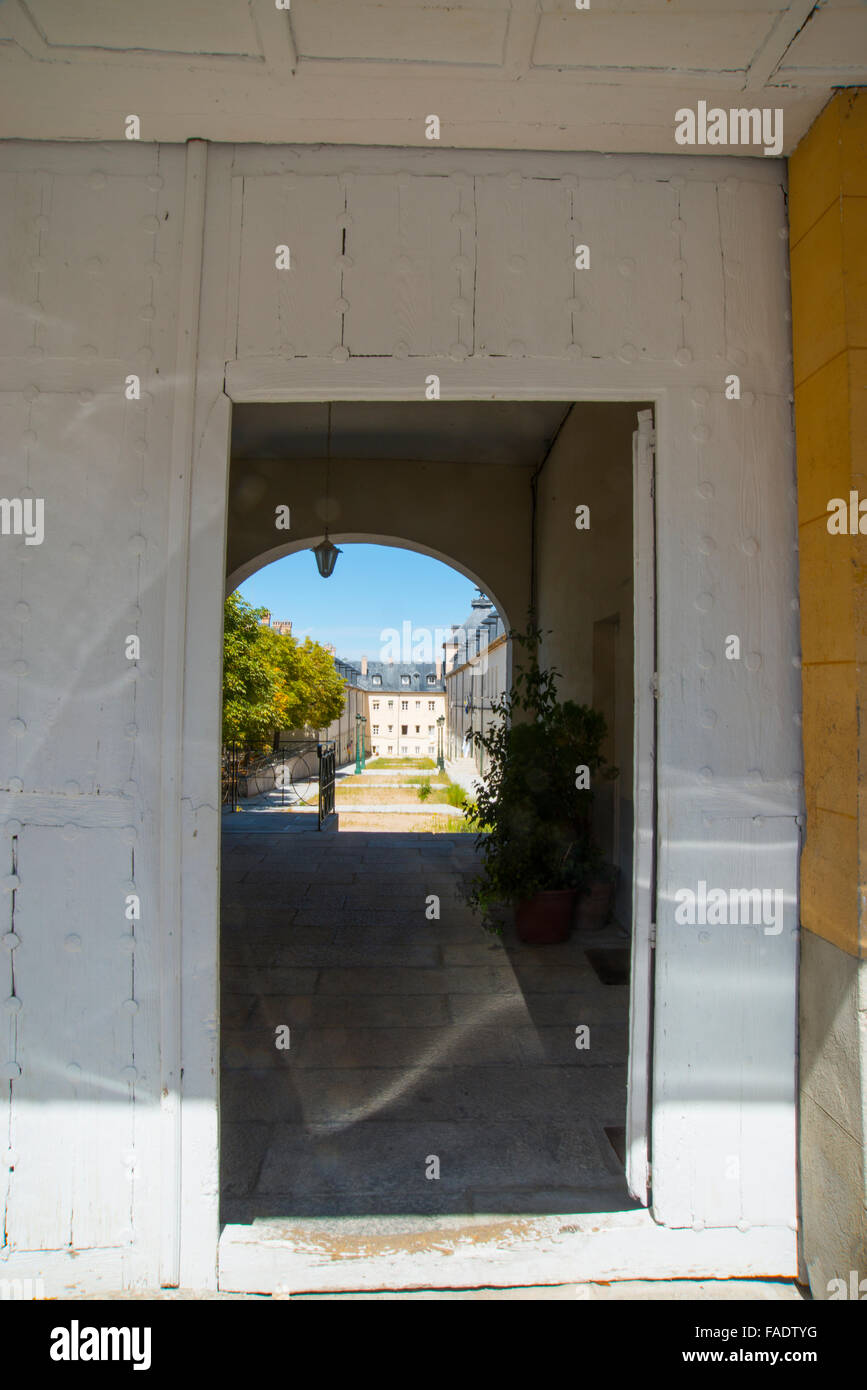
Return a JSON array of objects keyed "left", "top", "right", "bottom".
[{"left": 653, "top": 391, "right": 800, "bottom": 1226}]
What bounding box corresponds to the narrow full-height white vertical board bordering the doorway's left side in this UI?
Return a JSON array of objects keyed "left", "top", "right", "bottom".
[{"left": 168, "top": 150, "right": 232, "bottom": 1289}]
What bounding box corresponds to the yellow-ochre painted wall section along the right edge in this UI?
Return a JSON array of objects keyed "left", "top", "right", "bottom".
[{"left": 789, "top": 89, "right": 867, "bottom": 956}]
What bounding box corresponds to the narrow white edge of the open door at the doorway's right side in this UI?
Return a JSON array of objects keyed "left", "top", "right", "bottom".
[{"left": 627, "top": 410, "right": 659, "bottom": 1207}]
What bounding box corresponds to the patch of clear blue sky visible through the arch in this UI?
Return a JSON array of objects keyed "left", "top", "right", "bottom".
[{"left": 240, "top": 543, "right": 475, "bottom": 660}]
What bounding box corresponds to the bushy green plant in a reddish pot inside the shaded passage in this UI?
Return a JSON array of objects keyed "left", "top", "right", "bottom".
[{"left": 467, "top": 624, "right": 617, "bottom": 944}]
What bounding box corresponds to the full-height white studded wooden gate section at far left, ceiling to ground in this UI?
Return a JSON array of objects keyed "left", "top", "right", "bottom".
[{"left": 0, "top": 135, "right": 183, "bottom": 1297}]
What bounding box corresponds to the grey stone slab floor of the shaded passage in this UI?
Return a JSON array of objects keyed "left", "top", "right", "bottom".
[{"left": 221, "top": 823, "right": 635, "bottom": 1223}]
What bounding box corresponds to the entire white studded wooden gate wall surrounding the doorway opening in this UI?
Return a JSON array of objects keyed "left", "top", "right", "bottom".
[{"left": 0, "top": 135, "right": 800, "bottom": 1294}]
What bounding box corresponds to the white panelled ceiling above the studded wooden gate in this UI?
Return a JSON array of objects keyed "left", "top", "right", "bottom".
[{"left": 0, "top": 0, "right": 867, "bottom": 154}]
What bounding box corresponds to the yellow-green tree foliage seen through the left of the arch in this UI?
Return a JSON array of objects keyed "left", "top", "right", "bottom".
[{"left": 222, "top": 594, "right": 346, "bottom": 748}]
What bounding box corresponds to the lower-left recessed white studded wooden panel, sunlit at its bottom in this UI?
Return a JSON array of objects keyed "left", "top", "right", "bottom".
[{"left": 7, "top": 821, "right": 133, "bottom": 1250}]
